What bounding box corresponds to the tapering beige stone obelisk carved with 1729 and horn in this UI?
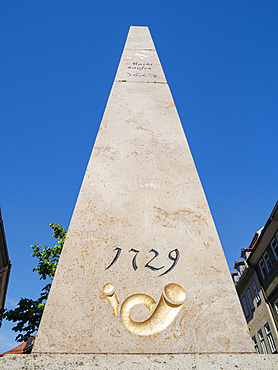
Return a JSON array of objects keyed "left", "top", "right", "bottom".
[{"left": 34, "top": 27, "right": 253, "bottom": 353}]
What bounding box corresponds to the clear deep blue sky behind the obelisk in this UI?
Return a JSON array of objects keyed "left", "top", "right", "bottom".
[{"left": 0, "top": 0, "right": 278, "bottom": 353}]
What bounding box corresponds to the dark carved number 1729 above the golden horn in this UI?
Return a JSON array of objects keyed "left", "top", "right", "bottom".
[{"left": 105, "top": 247, "right": 180, "bottom": 277}]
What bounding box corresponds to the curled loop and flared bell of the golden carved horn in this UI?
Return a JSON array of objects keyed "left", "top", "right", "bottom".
[{"left": 121, "top": 283, "right": 186, "bottom": 335}]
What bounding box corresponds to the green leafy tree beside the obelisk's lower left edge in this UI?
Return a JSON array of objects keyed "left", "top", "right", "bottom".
[{"left": 3, "top": 224, "right": 67, "bottom": 342}]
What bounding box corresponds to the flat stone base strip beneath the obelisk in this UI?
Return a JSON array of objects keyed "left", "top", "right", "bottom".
[{"left": 0, "top": 354, "right": 278, "bottom": 370}]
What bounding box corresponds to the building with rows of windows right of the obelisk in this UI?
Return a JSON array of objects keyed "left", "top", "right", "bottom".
[{"left": 232, "top": 202, "right": 278, "bottom": 354}]
